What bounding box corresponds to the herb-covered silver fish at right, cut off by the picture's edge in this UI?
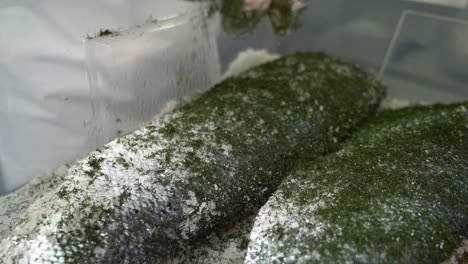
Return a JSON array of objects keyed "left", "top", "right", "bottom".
[{"left": 246, "top": 103, "right": 468, "bottom": 263}]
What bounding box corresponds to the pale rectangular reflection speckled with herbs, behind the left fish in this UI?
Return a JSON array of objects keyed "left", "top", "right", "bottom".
[{"left": 85, "top": 12, "right": 221, "bottom": 146}]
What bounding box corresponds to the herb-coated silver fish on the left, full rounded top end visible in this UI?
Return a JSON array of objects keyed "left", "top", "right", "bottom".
[{"left": 0, "top": 53, "right": 384, "bottom": 263}]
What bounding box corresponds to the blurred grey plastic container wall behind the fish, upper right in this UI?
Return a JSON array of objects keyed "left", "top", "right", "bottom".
[{"left": 218, "top": 0, "right": 468, "bottom": 102}]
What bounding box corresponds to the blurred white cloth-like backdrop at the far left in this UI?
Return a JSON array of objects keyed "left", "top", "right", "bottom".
[{"left": 0, "top": 0, "right": 212, "bottom": 196}]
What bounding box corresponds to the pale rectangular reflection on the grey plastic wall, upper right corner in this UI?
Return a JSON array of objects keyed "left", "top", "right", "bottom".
[{"left": 379, "top": 10, "right": 468, "bottom": 102}]
